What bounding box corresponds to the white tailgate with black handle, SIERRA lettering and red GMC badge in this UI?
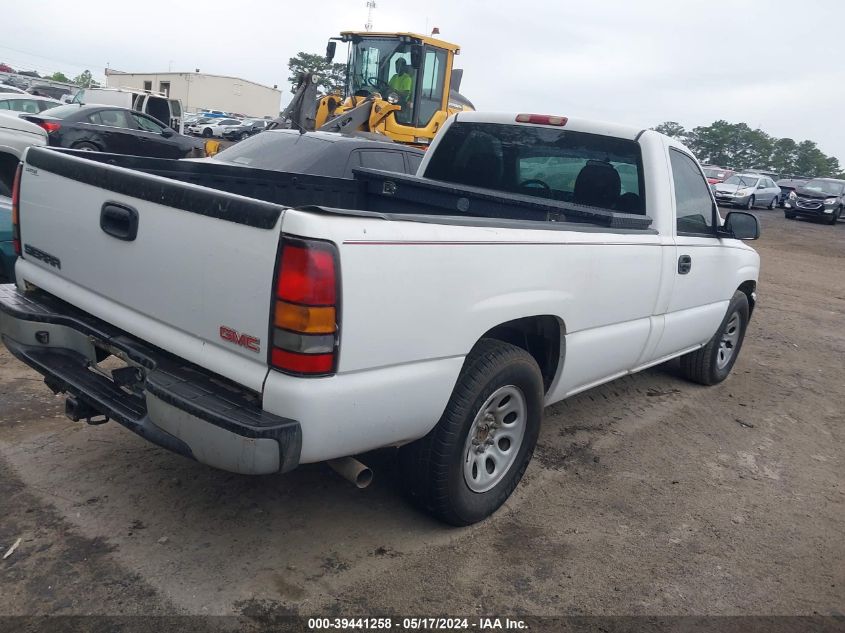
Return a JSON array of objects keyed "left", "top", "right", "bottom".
[{"left": 18, "top": 148, "right": 283, "bottom": 391}]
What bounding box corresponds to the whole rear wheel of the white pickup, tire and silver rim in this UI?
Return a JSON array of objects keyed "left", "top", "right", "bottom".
[{"left": 399, "top": 339, "right": 543, "bottom": 525}]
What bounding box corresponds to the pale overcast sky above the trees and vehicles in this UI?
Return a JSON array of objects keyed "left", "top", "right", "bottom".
[{"left": 0, "top": 0, "right": 845, "bottom": 164}]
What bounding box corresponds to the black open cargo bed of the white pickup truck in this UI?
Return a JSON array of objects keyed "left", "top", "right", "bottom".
[{"left": 44, "top": 150, "right": 652, "bottom": 231}]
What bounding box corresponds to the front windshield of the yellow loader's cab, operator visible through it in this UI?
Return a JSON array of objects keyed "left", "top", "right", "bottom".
[{"left": 347, "top": 37, "right": 417, "bottom": 124}]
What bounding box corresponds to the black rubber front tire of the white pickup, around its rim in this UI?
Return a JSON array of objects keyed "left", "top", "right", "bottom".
[{"left": 681, "top": 290, "right": 749, "bottom": 385}]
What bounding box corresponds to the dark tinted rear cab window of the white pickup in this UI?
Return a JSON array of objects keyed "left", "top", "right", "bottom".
[{"left": 425, "top": 121, "right": 646, "bottom": 215}]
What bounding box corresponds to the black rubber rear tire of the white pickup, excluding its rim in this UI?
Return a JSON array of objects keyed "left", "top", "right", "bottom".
[{"left": 399, "top": 339, "right": 543, "bottom": 526}]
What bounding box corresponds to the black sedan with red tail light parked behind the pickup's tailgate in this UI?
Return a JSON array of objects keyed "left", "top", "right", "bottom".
[{"left": 24, "top": 104, "right": 202, "bottom": 158}]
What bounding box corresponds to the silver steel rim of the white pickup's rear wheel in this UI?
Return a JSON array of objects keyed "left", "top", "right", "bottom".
[{"left": 463, "top": 385, "right": 528, "bottom": 493}]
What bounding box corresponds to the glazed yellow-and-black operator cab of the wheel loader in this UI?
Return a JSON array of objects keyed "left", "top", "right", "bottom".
[{"left": 340, "top": 32, "right": 472, "bottom": 143}]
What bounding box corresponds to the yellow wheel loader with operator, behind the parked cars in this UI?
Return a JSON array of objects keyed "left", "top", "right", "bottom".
[{"left": 274, "top": 31, "right": 475, "bottom": 147}]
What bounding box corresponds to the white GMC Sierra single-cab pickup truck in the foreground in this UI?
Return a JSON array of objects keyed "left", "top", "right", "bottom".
[{"left": 0, "top": 113, "right": 759, "bottom": 525}]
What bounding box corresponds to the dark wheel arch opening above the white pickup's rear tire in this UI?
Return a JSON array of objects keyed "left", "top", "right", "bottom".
[{"left": 476, "top": 314, "right": 566, "bottom": 393}]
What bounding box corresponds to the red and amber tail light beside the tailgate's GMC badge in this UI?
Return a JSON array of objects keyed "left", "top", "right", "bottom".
[{"left": 269, "top": 237, "right": 339, "bottom": 376}]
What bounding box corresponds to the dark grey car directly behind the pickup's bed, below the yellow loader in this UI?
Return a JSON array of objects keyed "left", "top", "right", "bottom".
[{"left": 206, "top": 130, "right": 424, "bottom": 178}]
